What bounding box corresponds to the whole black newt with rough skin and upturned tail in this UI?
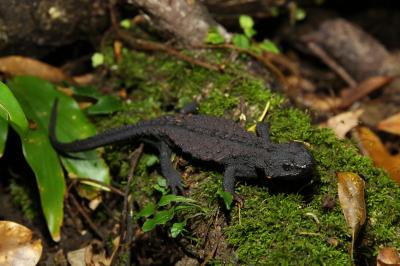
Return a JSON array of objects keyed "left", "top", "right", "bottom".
[{"left": 49, "top": 100, "right": 313, "bottom": 203}]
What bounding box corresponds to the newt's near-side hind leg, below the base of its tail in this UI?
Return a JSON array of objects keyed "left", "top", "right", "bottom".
[{"left": 157, "top": 142, "right": 183, "bottom": 194}]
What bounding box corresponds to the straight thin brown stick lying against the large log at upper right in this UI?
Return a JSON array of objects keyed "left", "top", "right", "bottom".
[{"left": 307, "top": 42, "right": 357, "bottom": 87}]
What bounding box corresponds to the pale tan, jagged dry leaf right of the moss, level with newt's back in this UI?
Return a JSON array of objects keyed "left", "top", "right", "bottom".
[{"left": 326, "top": 109, "right": 364, "bottom": 139}]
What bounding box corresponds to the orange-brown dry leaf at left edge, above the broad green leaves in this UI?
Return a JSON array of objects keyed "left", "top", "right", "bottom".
[{"left": 0, "top": 56, "right": 73, "bottom": 83}]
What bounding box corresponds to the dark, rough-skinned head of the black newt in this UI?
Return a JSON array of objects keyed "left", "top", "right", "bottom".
[{"left": 263, "top": 142, "right": 314, "bottom": 180}]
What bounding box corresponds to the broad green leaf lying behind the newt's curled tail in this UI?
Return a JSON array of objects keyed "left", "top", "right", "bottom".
[{"left": 10, "top": 77, "right": 110, "bottom": 184}]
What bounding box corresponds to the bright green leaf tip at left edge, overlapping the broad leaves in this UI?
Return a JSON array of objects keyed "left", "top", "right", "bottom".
[{"left": 0, "top": 81, "right": 28, "bottom": 136}]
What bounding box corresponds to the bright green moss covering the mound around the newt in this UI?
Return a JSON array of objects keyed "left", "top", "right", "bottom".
[{"left": 97, "top": 47, "right": 400, "bottom": 265}]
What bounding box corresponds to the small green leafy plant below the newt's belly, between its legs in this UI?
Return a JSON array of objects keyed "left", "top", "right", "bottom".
[{"left": 136, "top": 177, "right": 206, "bottom": 238}]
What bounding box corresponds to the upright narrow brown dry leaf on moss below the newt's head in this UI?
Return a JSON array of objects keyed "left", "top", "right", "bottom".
[{"left": 337, "top": 172, "right": 367, "bottom": 254}]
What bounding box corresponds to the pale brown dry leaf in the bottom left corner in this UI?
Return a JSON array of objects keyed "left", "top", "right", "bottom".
[{"left": 0, "top": 221, "right": 42, "bottom": 266}]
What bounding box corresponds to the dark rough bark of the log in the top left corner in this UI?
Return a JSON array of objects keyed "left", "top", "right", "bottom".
[{"left": 0, "top": 0, "right": 109, "bottom": 56}]
